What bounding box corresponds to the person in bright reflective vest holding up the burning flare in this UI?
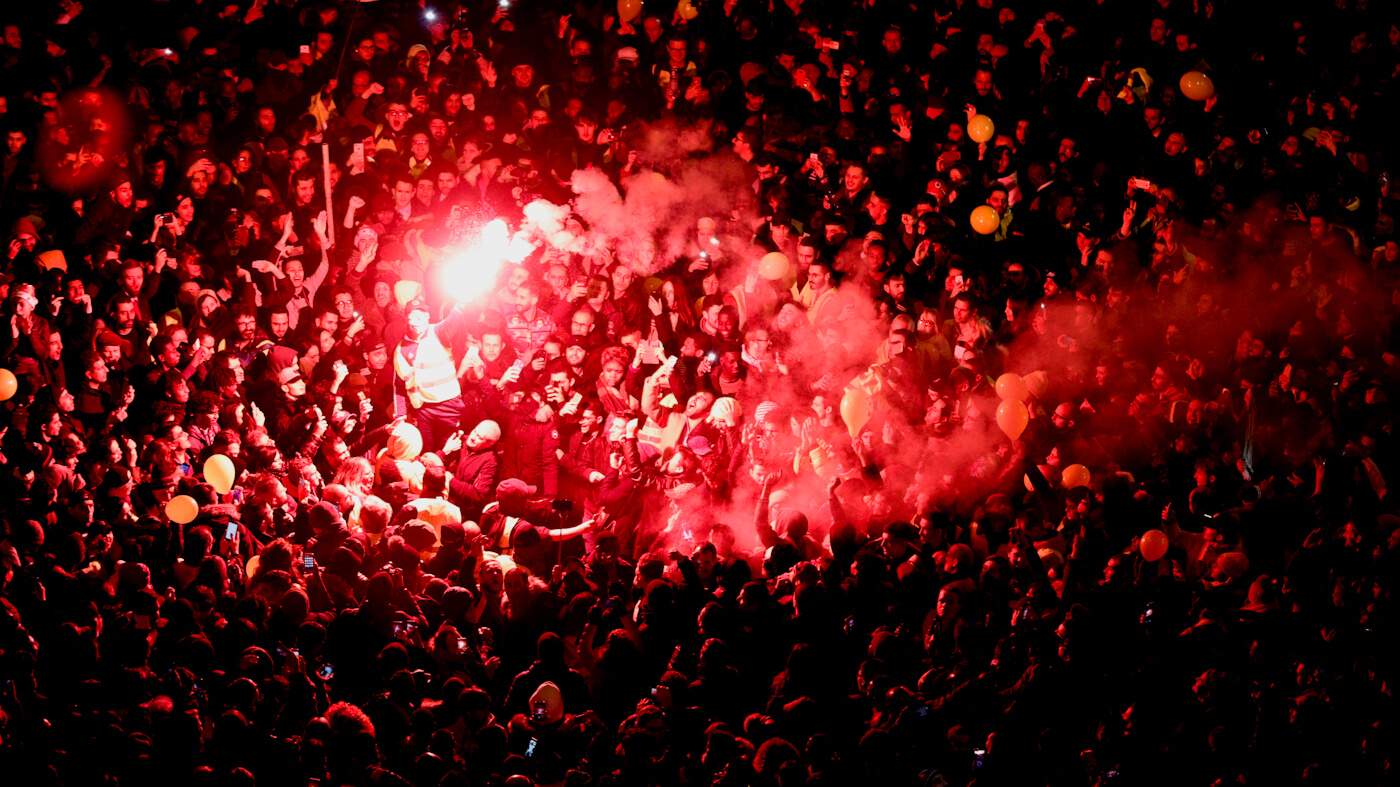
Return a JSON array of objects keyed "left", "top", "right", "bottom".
[{"left": 393, "top": 298, "right": 466, "bottom": 452}]
